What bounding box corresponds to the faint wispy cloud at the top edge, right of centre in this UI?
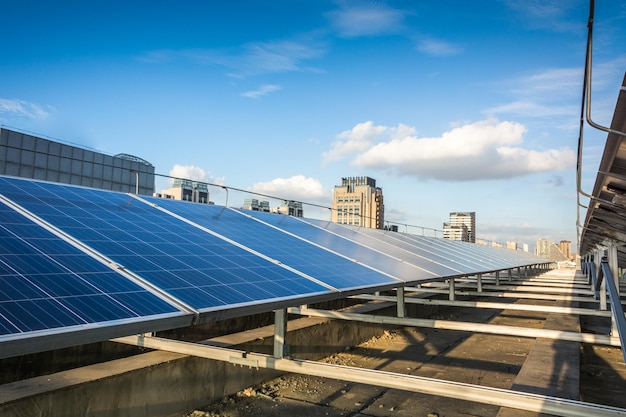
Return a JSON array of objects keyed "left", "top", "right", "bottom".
[{"left": 327, "top": 2, "right": 404, "bottom": 38}]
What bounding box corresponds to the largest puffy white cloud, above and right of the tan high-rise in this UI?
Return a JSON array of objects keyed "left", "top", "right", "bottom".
[{"left": 324, "top": 118, "right": 576, "bottom": 181}]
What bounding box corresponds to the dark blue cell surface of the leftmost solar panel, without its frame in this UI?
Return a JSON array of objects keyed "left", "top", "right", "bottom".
[{"left": 0, "top": 200, "right": 180, "bottom": 338}]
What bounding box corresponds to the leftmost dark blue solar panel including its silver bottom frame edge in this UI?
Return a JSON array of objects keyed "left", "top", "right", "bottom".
[{"left": 0, "top": 198, "right": 193, "bottom": 358}]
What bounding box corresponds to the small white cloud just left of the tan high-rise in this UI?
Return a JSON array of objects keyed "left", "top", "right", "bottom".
[{"left": 251, "top": 175, "right": 330, "bottom": 203}]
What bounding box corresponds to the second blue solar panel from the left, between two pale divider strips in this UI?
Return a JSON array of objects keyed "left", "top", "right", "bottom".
[{"left": 0, "top": 177, "right": 333, "bottom": 312}]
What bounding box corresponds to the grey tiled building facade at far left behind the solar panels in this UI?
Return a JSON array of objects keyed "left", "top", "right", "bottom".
[{"left": 0, "top": 128, "right": 154, "bottom": 195}]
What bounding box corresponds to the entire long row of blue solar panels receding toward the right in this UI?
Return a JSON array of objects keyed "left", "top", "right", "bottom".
[{"left": 0, "top": 176, "right": 542, "bottom": 357}]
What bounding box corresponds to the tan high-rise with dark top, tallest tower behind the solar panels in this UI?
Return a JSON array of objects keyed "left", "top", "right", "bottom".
[{"left": 331, "top": 177, "right": 385, "bottom": 229}]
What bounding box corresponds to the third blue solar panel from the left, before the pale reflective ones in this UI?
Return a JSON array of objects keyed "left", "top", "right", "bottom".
[{"left": 141, "top": 197, "right": 405, "bottom": 291}]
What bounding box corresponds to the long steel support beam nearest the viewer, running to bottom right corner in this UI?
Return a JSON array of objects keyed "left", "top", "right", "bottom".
[{"left": 114, "top": 336, "right": 626, "bottom": 417}]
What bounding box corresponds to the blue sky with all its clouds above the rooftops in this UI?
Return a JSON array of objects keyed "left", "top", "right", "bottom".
[{"left": 0, "top": 0, "right": 626, "bottom": 250}]
